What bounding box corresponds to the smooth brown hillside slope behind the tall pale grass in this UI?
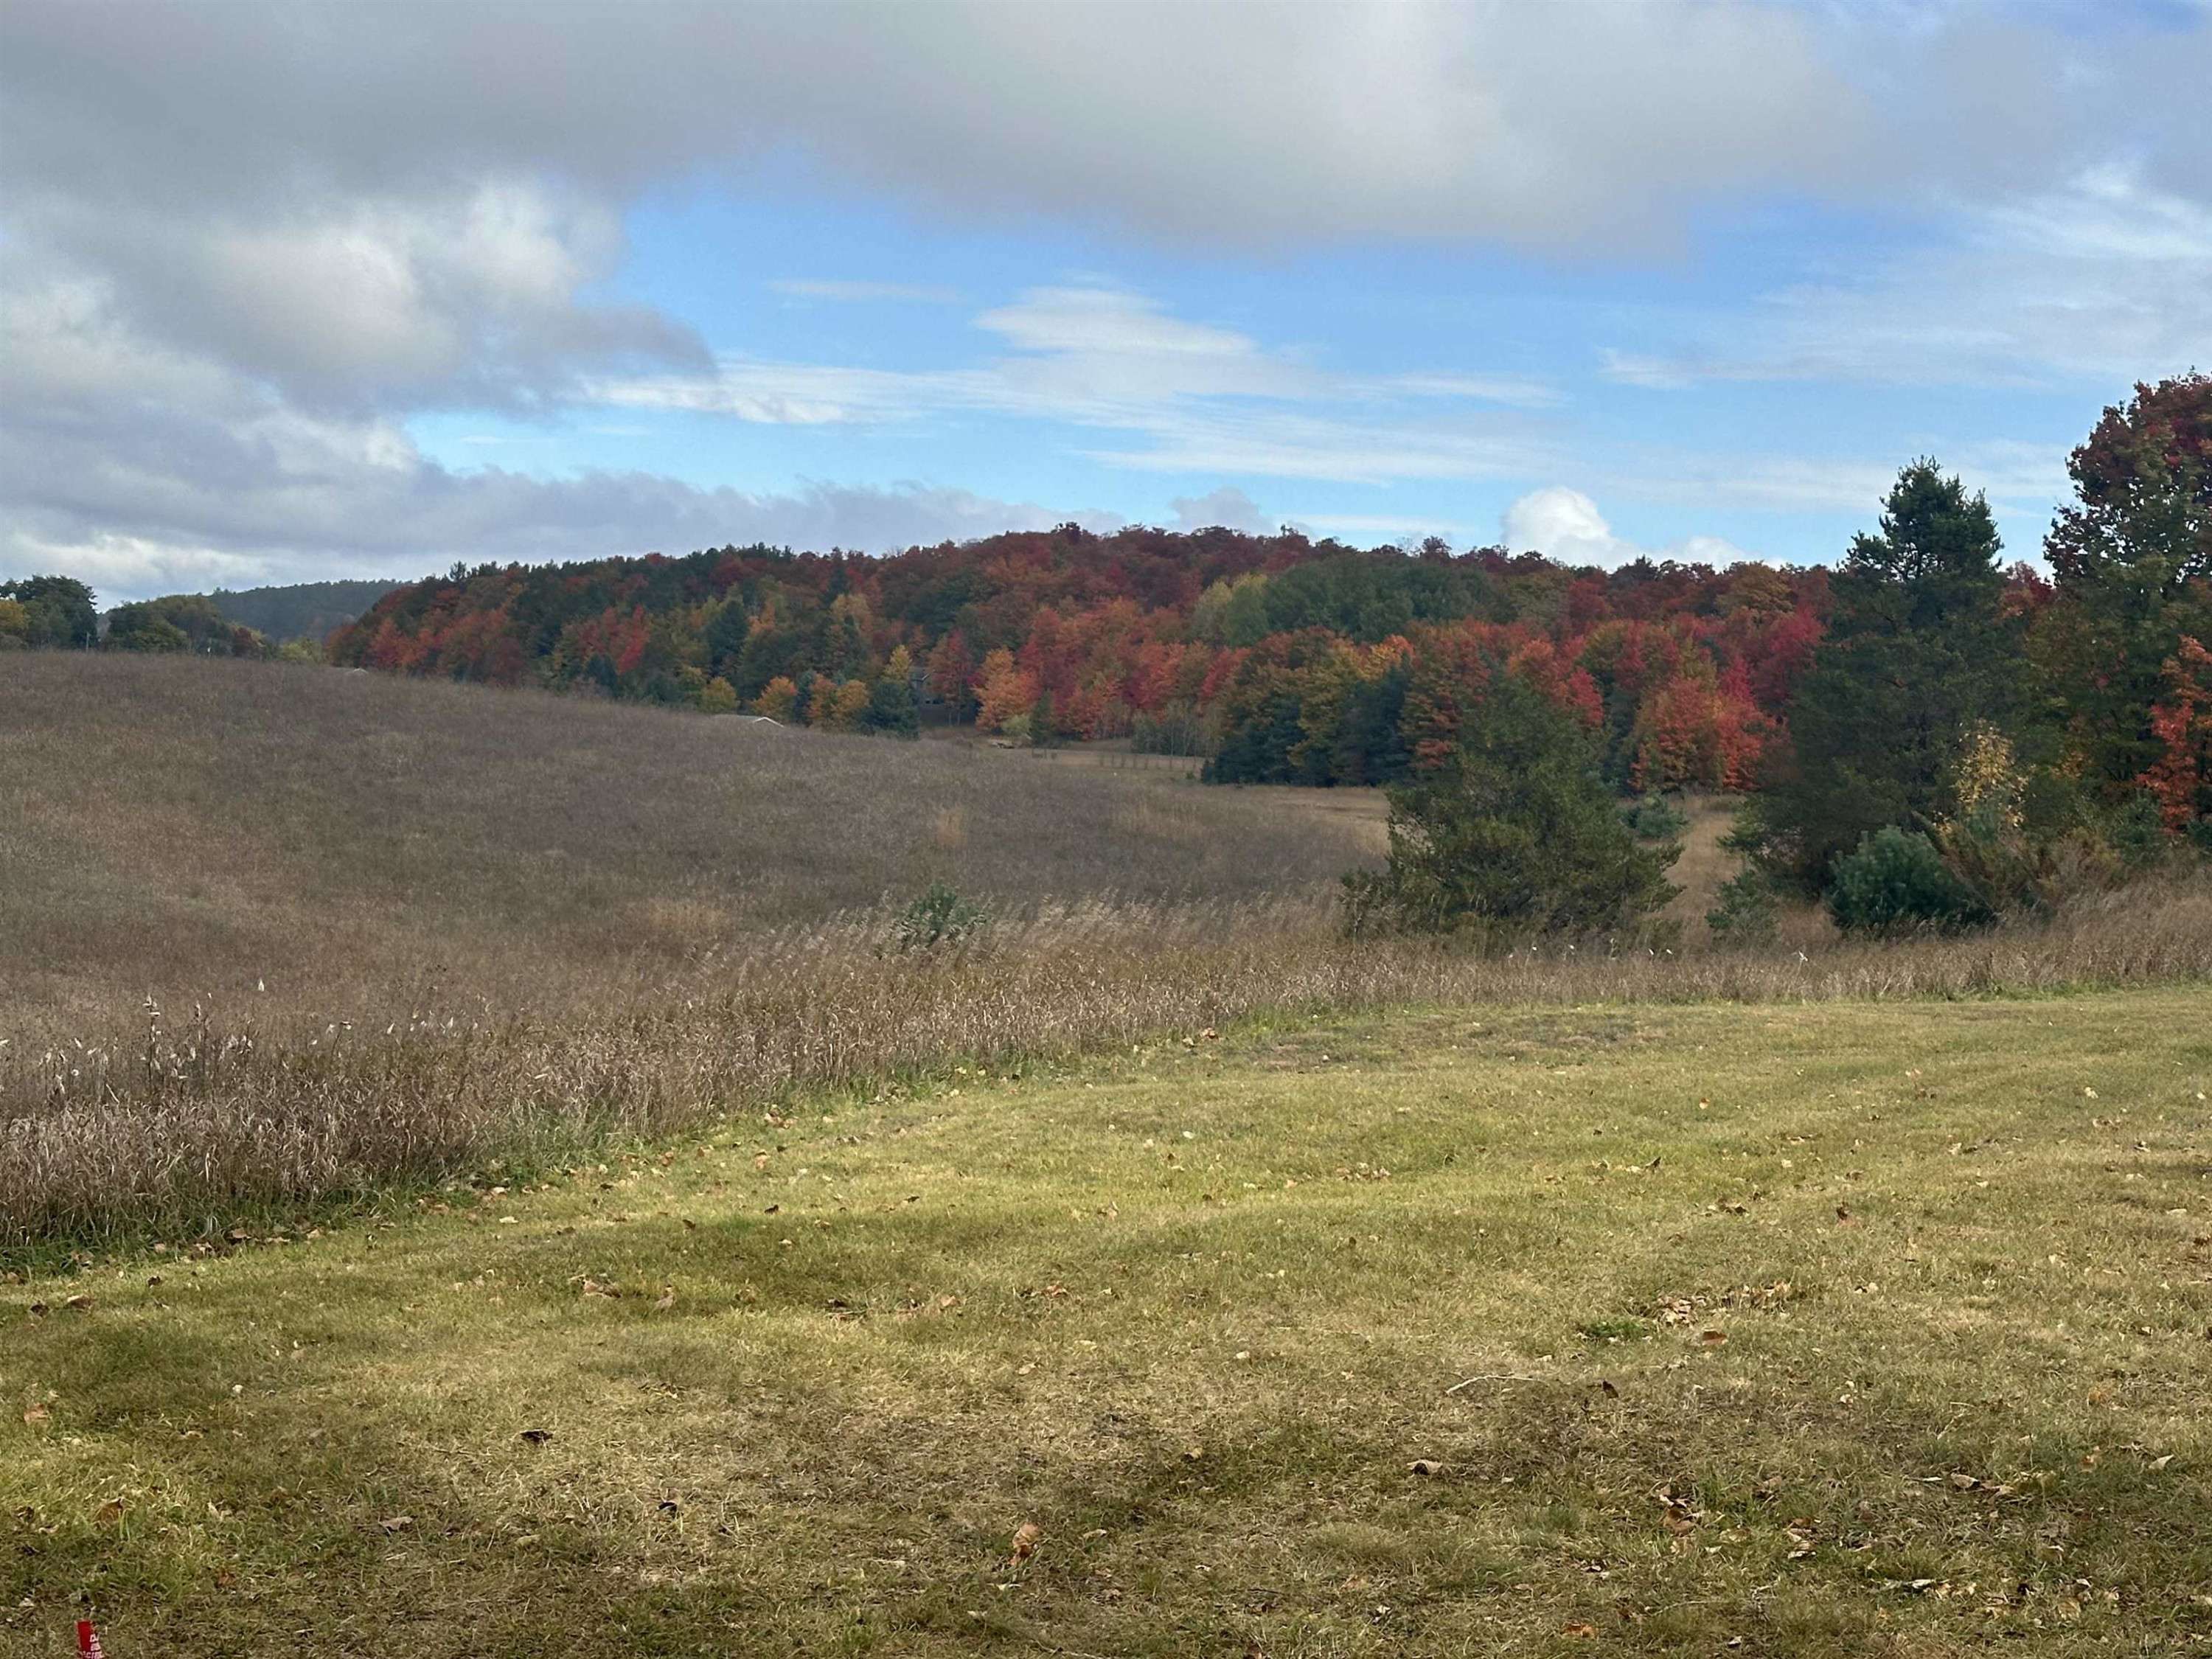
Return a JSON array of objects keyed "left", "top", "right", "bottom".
[{"left": 0, "top": 653, "right": 1376, "bottom": 1024}]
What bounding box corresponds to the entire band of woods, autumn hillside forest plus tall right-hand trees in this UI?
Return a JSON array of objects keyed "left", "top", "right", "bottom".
[{"left": 0, "top": 372, "right": 2212, "bottom": 922}]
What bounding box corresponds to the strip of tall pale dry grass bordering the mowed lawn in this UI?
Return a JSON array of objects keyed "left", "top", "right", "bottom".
[{"left": 0, "top": 880, "right": 2212, "bottom": 1248}]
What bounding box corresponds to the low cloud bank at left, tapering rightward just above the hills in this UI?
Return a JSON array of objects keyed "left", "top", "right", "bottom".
[{"left": 0, "top": 274, "right": 1121, "bottom": 602}]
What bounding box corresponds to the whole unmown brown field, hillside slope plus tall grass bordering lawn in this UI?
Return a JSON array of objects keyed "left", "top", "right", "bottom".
[{"left": 0, "top": 655, "right": 2212, "bottom": 1261}]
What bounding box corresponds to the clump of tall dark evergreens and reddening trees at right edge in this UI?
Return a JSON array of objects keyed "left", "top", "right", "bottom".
[{"left": 1721, "top": 374, "right": 2212, "bottom": 931}]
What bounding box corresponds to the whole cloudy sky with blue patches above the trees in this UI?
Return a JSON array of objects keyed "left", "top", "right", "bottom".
[{"left": 0, "top": 0, "right": 2212, "bottom": 602}]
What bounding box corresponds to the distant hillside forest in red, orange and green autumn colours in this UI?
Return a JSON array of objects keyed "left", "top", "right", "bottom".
[{"left": 312, "top": 507, "right": 1827, "bottom": 787}]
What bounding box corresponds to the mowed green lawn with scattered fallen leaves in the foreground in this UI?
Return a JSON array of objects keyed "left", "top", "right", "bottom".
[{"left": 0, "top": 989, "right": 2212, "bottom": 1659}]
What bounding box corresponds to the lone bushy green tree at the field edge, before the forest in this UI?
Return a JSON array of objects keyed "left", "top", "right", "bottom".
[{"left": 1345, "top": 677, "right": 1681, "bottom": 942}]
